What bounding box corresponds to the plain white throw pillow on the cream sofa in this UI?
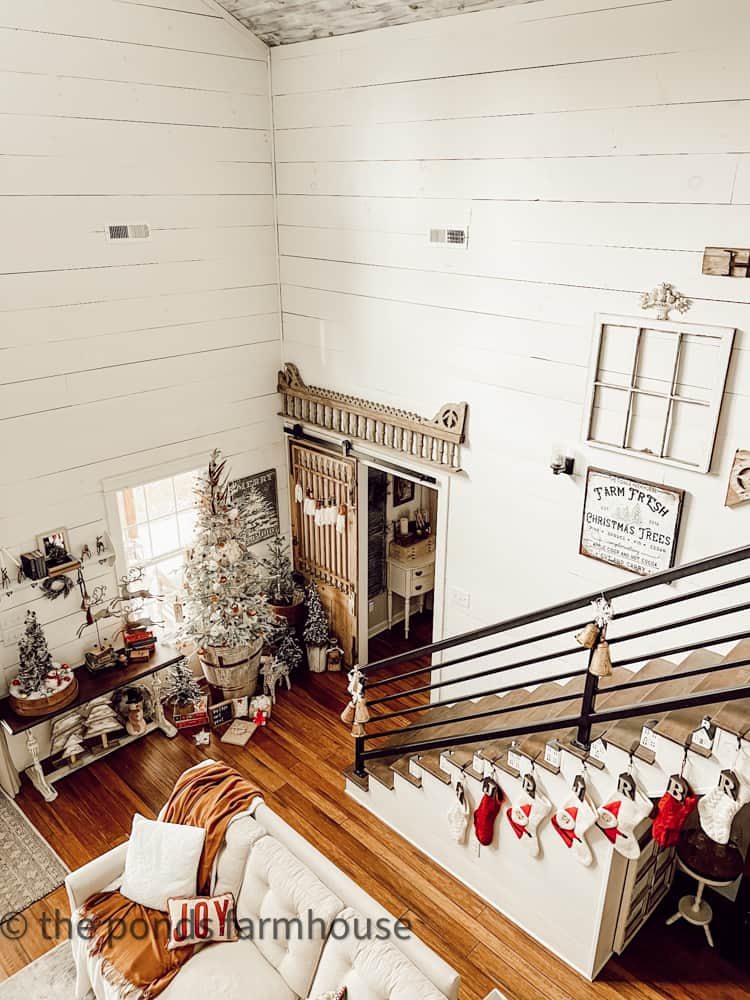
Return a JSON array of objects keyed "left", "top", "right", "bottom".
[{"left": 120, "top": 813, "right": 206, "bottom": 911}]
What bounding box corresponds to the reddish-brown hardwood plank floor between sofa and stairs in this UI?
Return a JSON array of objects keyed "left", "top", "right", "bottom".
[{"left": 0, "top": 620, "right": 750, "bottom": 1000}]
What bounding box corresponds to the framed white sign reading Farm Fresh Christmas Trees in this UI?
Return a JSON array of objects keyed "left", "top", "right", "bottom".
[{"left": 580, "top": 469, "right": 685, "bottom": 576}]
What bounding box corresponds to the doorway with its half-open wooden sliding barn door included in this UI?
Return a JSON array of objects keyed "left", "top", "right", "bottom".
[{"left": 289, "top": 432, "right": 449, "bottom": 667}]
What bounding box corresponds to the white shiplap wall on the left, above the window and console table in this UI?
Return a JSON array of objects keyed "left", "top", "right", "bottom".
[{"left": 0, "top": 0, "right": 285, "bottom": 700}]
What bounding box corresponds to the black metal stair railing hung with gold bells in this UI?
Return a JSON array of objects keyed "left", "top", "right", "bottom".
[{"left": 354, "top": 546, "right": 750, "bottom": 777}]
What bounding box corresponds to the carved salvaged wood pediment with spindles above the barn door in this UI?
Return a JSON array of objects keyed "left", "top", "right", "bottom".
[{"left": 278, "top": 364, "right": 469, "bottom": 471}]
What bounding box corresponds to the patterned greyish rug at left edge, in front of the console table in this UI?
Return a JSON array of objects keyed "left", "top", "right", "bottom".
[{"left": 0, "top": 793, "right": 69, "bottom": 915}]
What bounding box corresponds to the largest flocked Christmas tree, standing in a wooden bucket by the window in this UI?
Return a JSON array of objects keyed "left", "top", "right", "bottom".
[{"left": 180, "top": 450, "right": 272, "bottom": 648}]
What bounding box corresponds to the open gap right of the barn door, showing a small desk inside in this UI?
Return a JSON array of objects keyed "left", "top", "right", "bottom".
[{"left": 360, "top": 466, "right": 438, "bottom": 662}]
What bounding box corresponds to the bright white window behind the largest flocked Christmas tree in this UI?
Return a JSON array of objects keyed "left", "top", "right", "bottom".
[{"left": 117, "top": 470, "right": 199, "bottom": 624}]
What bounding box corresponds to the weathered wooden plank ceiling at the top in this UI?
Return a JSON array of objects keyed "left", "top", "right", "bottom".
[{"left": 213, "top": 0, "right": 548, "bottom": 45}]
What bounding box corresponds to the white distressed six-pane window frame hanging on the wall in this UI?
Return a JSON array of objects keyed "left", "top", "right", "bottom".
[{"left": 583, "top": 313, "right": 736, "bottom": 473}]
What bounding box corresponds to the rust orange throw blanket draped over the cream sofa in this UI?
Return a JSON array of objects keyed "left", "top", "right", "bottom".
[{"left": 81, "top": 763, "right": 260, "bottom": 1000}]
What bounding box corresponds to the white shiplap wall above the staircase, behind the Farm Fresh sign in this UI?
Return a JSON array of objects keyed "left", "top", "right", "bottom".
[{"left": 272, "top": 0, "right": 750, "bottom": 634}]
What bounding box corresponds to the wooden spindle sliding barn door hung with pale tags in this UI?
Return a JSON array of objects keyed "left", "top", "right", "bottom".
[{"left": 290, "top": 442, "right": 357, "bottom": 666}]
